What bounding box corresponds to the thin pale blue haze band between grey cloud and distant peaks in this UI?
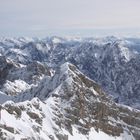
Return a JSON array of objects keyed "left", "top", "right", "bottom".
[{"left": 0, "top": 27, "right": 140, "bottom": 38}]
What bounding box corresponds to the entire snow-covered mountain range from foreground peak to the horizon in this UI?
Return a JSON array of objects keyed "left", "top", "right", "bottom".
[{"left": 0, "top": 36, "right": 140, "bottom": 140}]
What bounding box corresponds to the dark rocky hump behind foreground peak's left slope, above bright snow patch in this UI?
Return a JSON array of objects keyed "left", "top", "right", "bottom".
[{"left": 7, "top": 61, "right": 51, "bottom": 84}]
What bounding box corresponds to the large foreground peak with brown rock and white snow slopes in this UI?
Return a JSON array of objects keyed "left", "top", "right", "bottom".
[{"left": 0, "top": 63, "right": 140, "bottom": 140}]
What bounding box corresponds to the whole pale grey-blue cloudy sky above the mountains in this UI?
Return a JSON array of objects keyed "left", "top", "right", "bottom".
[{"left": 0, "top": 0, "right": 140, "bottom": 36}]
